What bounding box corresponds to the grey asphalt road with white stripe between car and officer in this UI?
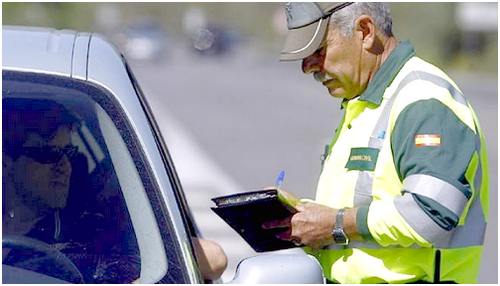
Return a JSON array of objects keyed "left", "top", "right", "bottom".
[{"left": 132, "top": 45, "right": 498, "bottom": 284}]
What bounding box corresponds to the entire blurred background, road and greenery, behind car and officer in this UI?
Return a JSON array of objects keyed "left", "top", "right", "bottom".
[{"left": 2, "top": 2, "right": 498, "bottom": 284}]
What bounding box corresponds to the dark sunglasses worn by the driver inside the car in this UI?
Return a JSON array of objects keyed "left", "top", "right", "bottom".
[{"left": 23, "top": 145, "right": 78, "bottom": 164}]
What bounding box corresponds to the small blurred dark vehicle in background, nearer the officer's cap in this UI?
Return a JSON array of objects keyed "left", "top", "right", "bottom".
[{"left": 191, "top": 26, "right": 242, "bottom": 56}]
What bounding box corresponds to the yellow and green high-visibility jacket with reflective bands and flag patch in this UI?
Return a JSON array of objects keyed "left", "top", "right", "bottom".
[{"left": 307, "top": 41, "right": 488, "bottom": 284}]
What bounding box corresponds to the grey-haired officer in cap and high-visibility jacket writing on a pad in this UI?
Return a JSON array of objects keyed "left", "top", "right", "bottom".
[{"left": 264, "top": 2, "right": 488, "bottom": 284}]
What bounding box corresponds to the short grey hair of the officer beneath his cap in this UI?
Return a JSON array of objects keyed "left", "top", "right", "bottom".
[{"left": 329, "top": 2, "right": 392, "bottom": 38}]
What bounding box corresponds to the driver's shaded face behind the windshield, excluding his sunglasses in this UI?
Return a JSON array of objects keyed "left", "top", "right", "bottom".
[{"left": 13, "top": 126, "right": 72, "bottom": 208}]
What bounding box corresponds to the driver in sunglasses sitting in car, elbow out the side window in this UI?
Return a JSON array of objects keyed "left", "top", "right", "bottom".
[{"left": 2, "top": 98, "right": 227, "bottom": 283}]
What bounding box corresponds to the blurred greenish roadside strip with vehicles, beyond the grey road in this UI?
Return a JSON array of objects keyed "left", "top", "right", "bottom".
[{"left": 2, "top": 2, "right": 498, "bottom": 73}]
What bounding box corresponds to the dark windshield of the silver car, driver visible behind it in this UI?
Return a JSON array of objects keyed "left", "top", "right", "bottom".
[{"left": 2, "top": 72, "right": 175, "bottom": 283}]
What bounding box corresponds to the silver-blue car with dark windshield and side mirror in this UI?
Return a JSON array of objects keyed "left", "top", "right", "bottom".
[{"left": 2, "top": 26, "right": 324, "bottom": 284}]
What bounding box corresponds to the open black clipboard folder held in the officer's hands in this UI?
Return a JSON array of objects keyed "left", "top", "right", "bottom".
[{"left": 212, "top": 189, "right": 298, "bottom": 252}]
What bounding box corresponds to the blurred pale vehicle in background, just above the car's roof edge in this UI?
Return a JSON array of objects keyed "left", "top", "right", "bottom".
[{"left": 111, "top": 20, "right": 170, "bottom": 62}]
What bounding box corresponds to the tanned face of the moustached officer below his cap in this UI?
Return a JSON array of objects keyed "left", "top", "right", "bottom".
[{"left": 302, "top": 26, "right": 364, "bottom": 99}]
